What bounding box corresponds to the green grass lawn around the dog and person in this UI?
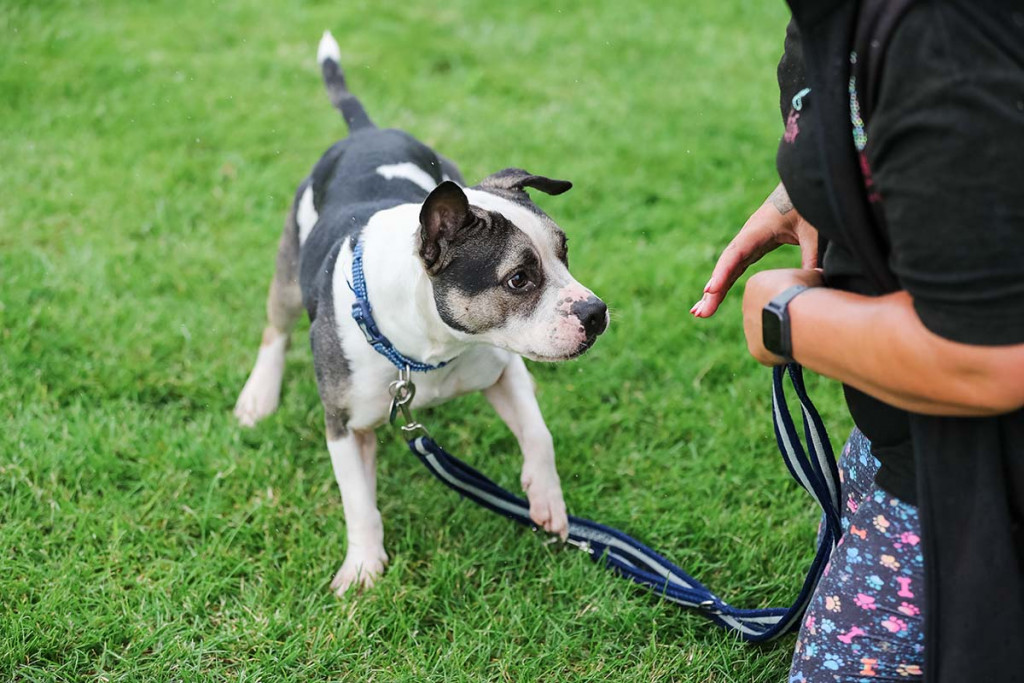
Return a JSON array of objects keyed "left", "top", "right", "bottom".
[{"left": 0, "top": 0, "right": 849, "bottom": 681}]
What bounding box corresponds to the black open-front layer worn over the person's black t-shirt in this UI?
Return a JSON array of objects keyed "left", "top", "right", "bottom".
[{"left": 790, "top": 0, "right": 1024, "bottom": 683}]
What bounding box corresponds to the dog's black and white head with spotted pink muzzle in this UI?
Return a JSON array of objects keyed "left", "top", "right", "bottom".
[{"left": 419, "top": 169, "right": 608, "bottom": 360}]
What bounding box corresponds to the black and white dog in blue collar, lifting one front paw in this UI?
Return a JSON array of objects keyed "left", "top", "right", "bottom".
[{"left": 234, "top": 32, "right": 608, "bottom": 595}]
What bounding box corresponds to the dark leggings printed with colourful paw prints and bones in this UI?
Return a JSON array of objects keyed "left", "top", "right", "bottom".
[{"left": 790, "top": 429, "right": 925, "bottom": 683}]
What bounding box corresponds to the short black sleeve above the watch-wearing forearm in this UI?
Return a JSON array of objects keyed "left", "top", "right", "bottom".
[{"left": 867, "top": 2, "right": 1024, "bottom": 345}]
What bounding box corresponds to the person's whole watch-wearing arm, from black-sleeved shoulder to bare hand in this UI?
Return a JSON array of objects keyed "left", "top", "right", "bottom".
[{"left": 743, "top": 13, "right": 1024, "bottom": 416}]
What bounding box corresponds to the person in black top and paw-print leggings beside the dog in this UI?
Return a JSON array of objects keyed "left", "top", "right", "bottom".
[{"left": 691, "top": 0, "right": 1024, "bottom": 683}]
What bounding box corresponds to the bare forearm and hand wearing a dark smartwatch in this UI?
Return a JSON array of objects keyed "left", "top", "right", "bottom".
[{"left": 743, "top": 270, "right": 1024, "bottom": 417}]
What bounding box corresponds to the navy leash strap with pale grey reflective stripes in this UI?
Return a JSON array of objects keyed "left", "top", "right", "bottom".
[{"left": 406, "top": 364, "right": 842, "bottom": 642}]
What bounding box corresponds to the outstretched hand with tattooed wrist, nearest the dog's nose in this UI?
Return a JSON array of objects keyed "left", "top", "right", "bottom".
[{"left": 690, "top": 182, "right": 818, "bottom": 317}]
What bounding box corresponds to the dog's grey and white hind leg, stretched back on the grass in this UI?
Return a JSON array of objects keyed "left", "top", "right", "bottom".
[{"left": 234, "top": 181, "right": 308, "bottom": 427}]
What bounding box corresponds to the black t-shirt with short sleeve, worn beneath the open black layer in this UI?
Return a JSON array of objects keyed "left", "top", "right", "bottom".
[{"left": 776, "top": 2, "right": 1024, "bottom": 503}]
